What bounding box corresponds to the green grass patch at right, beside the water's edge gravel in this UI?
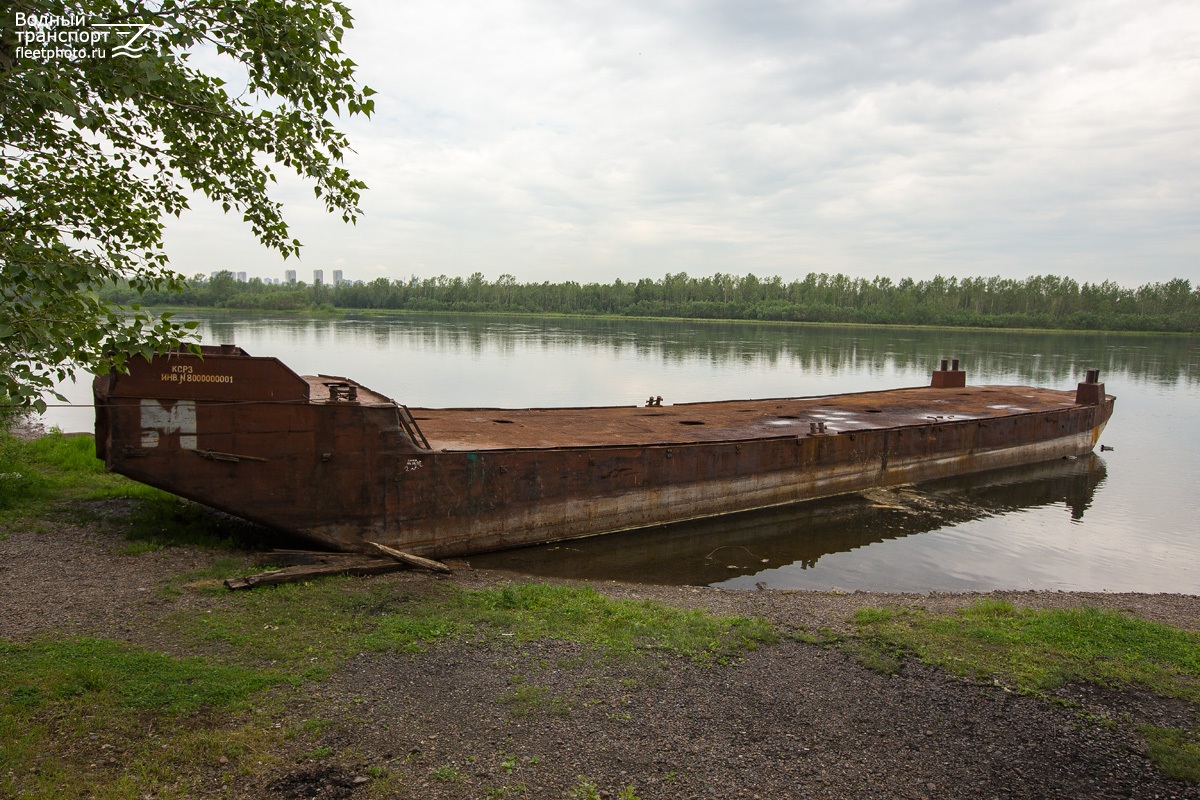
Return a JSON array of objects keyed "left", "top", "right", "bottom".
[{"left": 856, "top": 601, "right": 1200, "bottom": 702}]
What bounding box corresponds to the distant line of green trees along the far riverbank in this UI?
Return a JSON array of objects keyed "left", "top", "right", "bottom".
[{"left": 104, "top": 272, "right": 1200, "bottom": 331}]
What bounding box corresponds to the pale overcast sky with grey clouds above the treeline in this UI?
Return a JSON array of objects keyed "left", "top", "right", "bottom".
[{"left": 168, "top": 0, "right": 1200, "bottom": 285}]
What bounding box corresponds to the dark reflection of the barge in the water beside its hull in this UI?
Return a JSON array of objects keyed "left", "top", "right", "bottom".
[{"left": 469, "top": 453, "right": 1105, "bottom": 588}]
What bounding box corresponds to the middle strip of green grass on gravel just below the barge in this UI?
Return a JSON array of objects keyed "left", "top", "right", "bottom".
[{"left": 174, "top": 578, "right": 776, "bottom": 675}]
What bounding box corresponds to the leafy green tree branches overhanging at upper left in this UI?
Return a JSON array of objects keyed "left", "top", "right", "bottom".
[{"left": 0, "top": 0, "right": 373, "bottom": 410}]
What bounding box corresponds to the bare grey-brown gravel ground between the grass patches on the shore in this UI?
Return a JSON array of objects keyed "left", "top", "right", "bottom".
[{"left": 0, "top": 515, "right": 1200, "bottom": 800}]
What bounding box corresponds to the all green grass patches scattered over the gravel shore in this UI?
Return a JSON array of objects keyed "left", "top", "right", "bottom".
[{"left": 0, "top": 434, "right": 1200, "bottom": 800}]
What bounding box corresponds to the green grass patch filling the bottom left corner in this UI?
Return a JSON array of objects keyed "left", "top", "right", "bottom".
[{"left": 0, "top": 638, "right": 284, "bottom": 798}]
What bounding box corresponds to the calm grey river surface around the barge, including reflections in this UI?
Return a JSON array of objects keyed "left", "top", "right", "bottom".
[{"left": 47, "top": 313, "right": 1200, "bottom": 594}]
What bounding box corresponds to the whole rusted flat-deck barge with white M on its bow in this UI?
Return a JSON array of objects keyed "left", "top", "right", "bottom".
[{"left": 94, "top": 345, "right": 1114, "bottom": 557}]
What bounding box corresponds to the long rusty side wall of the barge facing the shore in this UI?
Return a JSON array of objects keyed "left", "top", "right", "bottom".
[{"left": 372, "top": 414, "right": 1103, "bottom": 557}]
